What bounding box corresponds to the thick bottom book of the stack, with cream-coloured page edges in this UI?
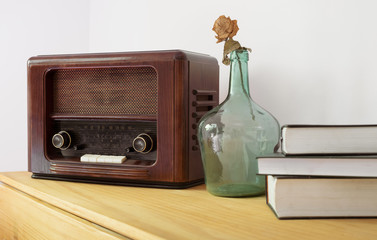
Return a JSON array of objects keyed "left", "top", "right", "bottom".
[{"left": 267, "top": 176, "right": 377, "bottom": 218}]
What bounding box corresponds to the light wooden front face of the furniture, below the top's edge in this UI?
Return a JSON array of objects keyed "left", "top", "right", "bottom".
[{"left": 0, "top": 183, "right": 128, "bottom": 240}]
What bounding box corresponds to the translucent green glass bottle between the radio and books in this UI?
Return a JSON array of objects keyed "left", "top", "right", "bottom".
[{"left": 198, "top": 50, "right": 280, "bottom": 197}]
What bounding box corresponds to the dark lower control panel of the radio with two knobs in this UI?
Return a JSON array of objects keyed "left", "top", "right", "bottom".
[{"left": 46, "top": 119, "right": 157, "bottom": 163}]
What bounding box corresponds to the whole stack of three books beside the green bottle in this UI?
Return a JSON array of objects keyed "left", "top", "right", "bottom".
[{"left": 258, "top": 125, "right": 377, "bottom": 218}]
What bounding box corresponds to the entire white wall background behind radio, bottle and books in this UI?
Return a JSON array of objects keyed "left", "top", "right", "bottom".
[{"left": 0, "top": 0, "right": 377, "bottom": 171}]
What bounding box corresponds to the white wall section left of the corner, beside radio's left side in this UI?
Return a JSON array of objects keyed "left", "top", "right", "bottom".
[{"left": 0, "top": 0, "right": 89, "bottom": 172}]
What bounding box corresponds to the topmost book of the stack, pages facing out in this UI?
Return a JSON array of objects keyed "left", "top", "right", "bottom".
[{"left": 282, "top": 125, "right": 377, "bottom": 155}]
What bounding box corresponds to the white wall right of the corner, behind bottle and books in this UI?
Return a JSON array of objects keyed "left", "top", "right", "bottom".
[{"left": 90, "top": 0, "right": 377, "bottom": 124}]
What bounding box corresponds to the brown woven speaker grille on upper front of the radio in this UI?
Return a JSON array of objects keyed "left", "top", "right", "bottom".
[{"left": 47, "top": 67, "right": 157, "bottom": 116}]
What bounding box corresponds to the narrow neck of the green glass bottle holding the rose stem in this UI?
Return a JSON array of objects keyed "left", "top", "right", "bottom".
[{"left": 228, "top": 50, "right": 250, "bottom": 97}]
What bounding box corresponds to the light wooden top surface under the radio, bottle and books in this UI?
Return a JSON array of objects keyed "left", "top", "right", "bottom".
[{"left": 0, "top": 172, "right": 377, "bottom": 240}]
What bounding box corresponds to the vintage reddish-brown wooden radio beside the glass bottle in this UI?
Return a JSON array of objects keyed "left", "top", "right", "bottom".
[{"left": 28, "top": 50, "right": 219, "bottom": 188}]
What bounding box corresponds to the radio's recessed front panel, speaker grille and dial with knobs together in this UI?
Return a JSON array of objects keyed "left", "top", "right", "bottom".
[{"left": 45, "top": 66, "right": 158, "bottom": 166}]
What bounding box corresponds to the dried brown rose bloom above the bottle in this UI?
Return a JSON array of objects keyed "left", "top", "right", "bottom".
[{"left": 212, "top": 15, "right": 238, "bottom": 43}]
